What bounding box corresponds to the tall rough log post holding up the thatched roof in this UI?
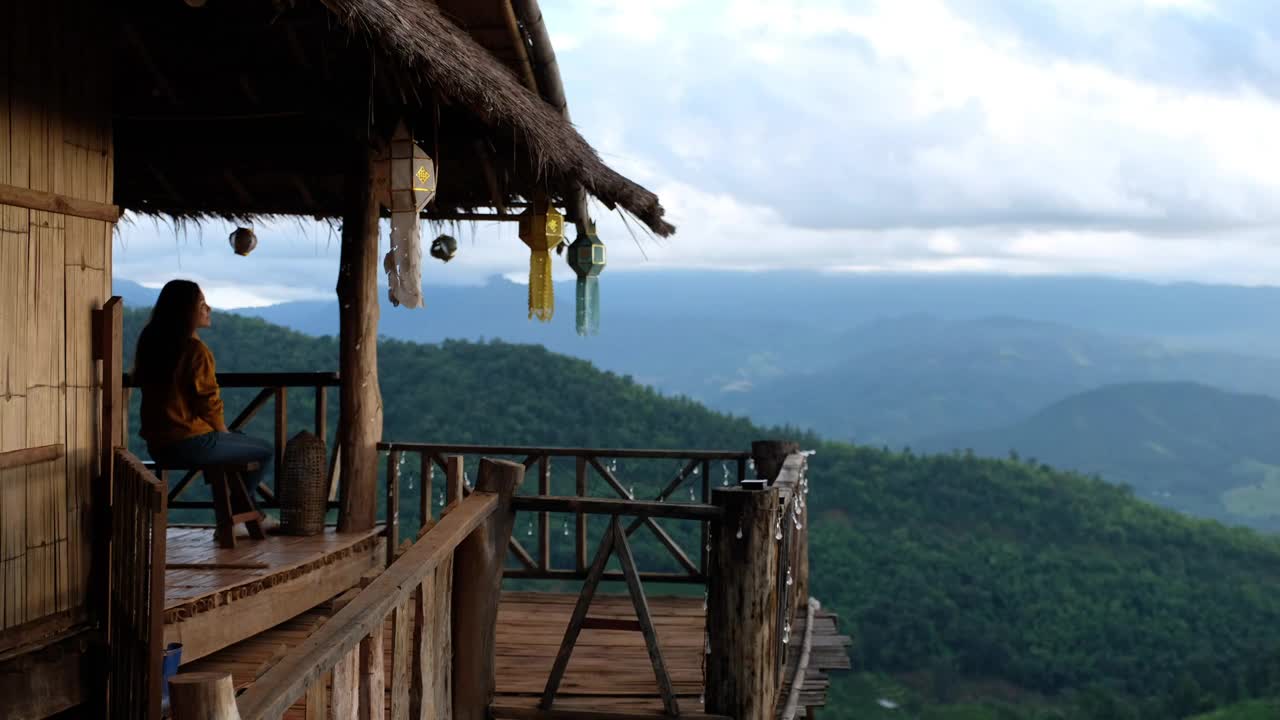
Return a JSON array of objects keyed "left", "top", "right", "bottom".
[{"left": 338, "top": 149, "right": 383, "bottom": 532}]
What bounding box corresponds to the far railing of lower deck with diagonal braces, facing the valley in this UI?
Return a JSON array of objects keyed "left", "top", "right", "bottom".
[{"left": 378, "top": 442, "right": 754, "bottom": 583}]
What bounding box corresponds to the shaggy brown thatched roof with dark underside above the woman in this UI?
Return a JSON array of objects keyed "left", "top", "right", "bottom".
[{"left": 114, "top": 0, "right": 673, "bottom": 234}]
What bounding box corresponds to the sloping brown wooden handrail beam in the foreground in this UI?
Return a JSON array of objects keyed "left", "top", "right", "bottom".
[{"left": 239, "top": 492, "right": 499, "bottom": 717}]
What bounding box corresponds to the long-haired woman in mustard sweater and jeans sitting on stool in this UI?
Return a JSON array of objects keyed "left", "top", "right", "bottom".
[{"left": 133, "top": 281, "right": 273, "bottom": 502}]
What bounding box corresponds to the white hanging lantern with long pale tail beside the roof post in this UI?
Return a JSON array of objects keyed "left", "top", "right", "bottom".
[{"left": 378, "top": 122, "right": 436, "bottom": 307}]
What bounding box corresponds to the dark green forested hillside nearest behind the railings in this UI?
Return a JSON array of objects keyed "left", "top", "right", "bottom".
[{"left": 127, "top": 313, "right": 1280, "bottom": 720}]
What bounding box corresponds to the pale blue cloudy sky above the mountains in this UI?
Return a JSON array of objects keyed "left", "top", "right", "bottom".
[{"left": 114, "top": 0, "right": 1280, "bottom": 307}]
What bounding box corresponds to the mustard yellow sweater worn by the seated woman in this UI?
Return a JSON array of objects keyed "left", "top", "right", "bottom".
[{"left": 138, "top": 337, "right": 224, "bottom": 450}]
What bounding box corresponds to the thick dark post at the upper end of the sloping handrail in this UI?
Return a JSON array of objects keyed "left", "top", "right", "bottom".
[{"left": 453, "top": 457, "right": 525, "bottom": 720}]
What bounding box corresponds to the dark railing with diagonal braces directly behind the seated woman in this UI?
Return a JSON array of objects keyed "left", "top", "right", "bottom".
[{"left": 123, "top": 373, "right": 342, "bottom": 510}]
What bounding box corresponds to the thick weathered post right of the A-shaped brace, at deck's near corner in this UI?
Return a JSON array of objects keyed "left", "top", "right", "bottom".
[{"left": 707, "top": 488, "right": 781, "bottom": 720}]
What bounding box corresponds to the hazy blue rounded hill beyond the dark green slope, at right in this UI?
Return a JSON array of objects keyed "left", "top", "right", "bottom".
[{"left": 918, "top": 383, "right": 1280, "bottom": 532}]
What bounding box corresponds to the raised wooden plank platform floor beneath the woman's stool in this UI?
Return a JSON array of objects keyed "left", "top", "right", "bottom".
[{"left": 165, "top": 527, "right": 384, "bottom": 661}]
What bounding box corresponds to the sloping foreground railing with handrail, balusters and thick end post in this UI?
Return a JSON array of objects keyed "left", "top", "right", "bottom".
[{"left": 172, "top": 460, "right": 524, "bottom": 720}]
